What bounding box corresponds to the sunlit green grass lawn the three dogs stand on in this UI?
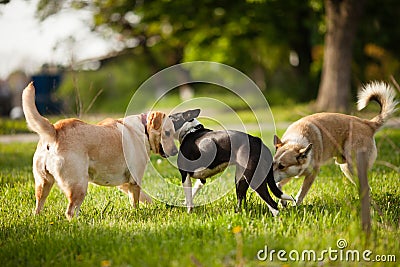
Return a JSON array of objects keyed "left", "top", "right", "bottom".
[{"left": 0, "top": 129, "right": 400, "bottom": 266}]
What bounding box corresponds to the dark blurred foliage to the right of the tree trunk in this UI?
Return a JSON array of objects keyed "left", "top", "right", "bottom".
[{"left": 353, "top": 0, "right": 400, "bottom": 86}]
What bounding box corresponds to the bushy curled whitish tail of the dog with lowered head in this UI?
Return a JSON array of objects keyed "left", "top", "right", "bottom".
[{"left": 357, "top": 82, "right": 399, "bottom": 128}]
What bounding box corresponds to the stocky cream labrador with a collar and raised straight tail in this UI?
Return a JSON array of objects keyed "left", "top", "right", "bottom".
[{"left": 22, "top": 83, "right": 178, "bottom": 219}]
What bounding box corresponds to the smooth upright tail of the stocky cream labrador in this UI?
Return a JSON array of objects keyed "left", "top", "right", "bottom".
[{"left": 22, "top": 82, "right": 56, "bottom": 141}]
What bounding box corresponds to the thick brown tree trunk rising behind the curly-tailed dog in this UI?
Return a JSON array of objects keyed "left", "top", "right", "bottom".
[{"left": 316, "top": 0, "right": 364, "bottom": 112}]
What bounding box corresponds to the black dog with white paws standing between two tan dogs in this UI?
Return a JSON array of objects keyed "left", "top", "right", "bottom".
[{"left": 170, "top": 109, "right": 293, "bottom": 216}]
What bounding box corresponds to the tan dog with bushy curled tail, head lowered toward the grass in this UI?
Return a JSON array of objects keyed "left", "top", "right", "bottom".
[{"left": 273, "top": 82, "right": 398, "bottom": 205}]
